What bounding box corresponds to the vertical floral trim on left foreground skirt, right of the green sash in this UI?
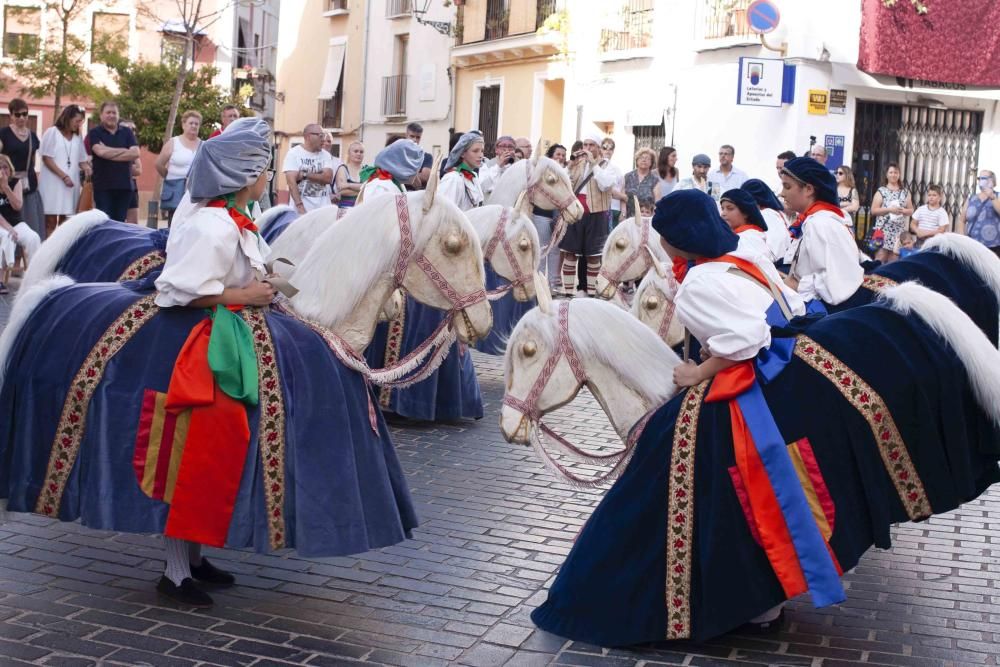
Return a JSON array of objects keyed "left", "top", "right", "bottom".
[{"left": 240, "top": 307, "right": 286, "bottom": 549}]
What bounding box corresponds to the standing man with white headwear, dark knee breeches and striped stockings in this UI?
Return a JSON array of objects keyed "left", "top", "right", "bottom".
[{"left": 559, "top": 131, "right": 616, "bottom": 296}]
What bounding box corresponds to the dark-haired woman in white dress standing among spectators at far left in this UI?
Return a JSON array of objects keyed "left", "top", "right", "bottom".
[{"left": 38, "top": 104, "right": 90, "bottom": 236}]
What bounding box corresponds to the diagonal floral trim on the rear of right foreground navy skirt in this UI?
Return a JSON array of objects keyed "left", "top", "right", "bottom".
[{"left": 795, "top": 336, "right": 933, "bottom": 521}]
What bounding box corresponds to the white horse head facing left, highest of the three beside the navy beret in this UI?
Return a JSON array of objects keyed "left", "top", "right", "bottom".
[{"left": 597, "top": 201, "right": 670, "bottom": 299}]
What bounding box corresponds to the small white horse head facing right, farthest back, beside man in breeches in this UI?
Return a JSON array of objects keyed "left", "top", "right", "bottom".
[{"left": 486, "top": 153, "right": 583, "bottom": 222}]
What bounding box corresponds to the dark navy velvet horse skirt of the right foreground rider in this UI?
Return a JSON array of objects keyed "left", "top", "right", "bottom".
[{"left": 532, "top": 304, "right": 1000, "bottom": 646}]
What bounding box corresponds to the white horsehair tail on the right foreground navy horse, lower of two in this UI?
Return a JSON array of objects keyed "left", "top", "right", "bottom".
[{"left": 881, "top": 281, "right": 1000, "bottom": 426}]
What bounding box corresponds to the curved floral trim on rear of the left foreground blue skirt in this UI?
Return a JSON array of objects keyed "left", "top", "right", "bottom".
[{"left": 35, "top": 294, "right": 160, "bottom": 516}]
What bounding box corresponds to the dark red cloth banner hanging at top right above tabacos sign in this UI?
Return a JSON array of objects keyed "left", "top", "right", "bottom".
[{"left": 858, "top": 0, "right": 1000, "bottom": 89}]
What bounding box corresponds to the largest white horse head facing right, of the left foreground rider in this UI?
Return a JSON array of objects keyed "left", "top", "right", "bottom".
[{"left": 283, "top": 164, "right": 493, "bottom": 350}]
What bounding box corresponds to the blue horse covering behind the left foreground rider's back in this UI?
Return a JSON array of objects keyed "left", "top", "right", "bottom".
[{"left": 56, "top": 220, "right": 170, "bottom": 283}]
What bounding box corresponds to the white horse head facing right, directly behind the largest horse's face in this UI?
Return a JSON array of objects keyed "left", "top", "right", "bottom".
[{"left": 465, "top": 193, "right": 542, "bottom": 301}]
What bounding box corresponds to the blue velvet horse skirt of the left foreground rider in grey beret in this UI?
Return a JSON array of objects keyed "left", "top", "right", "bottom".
[{"left": 0, "top": 284, "right": 417, "bottom": 557}]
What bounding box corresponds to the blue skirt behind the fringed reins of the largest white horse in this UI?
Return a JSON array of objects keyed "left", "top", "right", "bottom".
[{"left": 365, "top": 296, "right": 483, "bottom": 421}]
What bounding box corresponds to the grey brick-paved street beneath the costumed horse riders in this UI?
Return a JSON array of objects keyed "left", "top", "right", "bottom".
[{"left": 0, "top": 288, "right": 1000, "bottom": 667}]
